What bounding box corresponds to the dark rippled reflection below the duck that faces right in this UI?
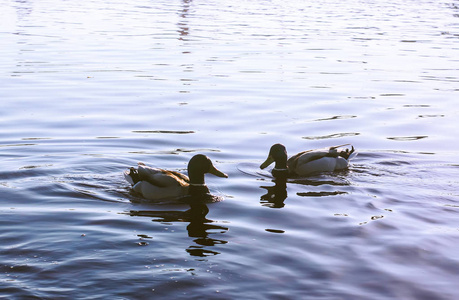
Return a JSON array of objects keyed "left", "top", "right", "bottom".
[{"left": 129, "top": 195, "right": 228, "bottom": 257}]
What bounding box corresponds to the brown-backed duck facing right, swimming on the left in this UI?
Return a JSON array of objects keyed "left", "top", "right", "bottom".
[{"left": 124, "top": 154, "right": 228, "bottom": 200}]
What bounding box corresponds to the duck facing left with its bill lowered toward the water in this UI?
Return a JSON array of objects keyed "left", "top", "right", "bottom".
[{"left": 260, "top": 144, "right": 357, "bottom": 178}]
